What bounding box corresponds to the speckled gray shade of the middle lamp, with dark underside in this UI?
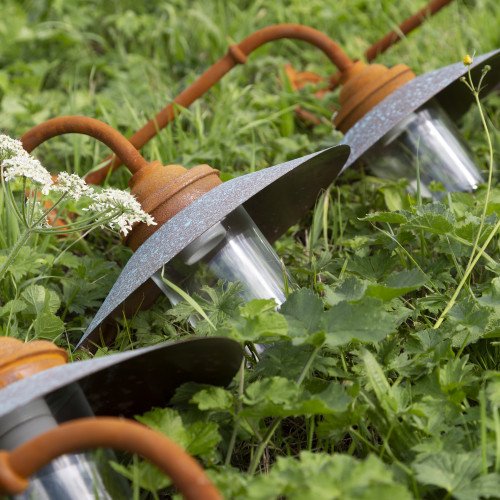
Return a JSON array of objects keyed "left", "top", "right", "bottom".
[{"left": 79, "top": 146, "right": 350, "bottom": 345}]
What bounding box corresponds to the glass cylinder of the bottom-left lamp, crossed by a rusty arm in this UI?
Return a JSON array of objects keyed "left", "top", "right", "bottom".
[{"left": 0, "top": 398, "right": 130, "bottom": 500}]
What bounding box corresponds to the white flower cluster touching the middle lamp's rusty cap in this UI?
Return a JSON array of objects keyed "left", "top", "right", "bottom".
[{"left": 87, "top": 188, "right": 156, "bottom": 236}]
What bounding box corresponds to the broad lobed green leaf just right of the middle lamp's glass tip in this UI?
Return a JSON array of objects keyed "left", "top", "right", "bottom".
[{"left": 322, "top": 297, "right": 395, "bottom": 347}]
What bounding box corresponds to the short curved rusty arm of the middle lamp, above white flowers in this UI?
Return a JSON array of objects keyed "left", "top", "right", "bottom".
[{"left": 21, "top": 116, "right": 149, "bottom": 173}]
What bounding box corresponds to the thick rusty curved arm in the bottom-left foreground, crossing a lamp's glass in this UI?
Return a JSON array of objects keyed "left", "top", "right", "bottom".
[{"left": 0, "top": 417, "right": 222, "bottom": 500}]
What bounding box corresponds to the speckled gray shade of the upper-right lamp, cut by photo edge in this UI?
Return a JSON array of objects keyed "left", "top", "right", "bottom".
[{"left": 342, "top": 50, "right": 500, "bottom": 169}]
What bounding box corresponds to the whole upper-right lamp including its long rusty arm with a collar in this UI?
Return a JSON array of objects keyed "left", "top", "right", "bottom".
[{"left": 72, "top": 21, "right": 499, "bottom": 196}]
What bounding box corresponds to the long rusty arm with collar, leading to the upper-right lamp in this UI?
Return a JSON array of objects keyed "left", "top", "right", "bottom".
[{"left": 86, "top": 24, "right": 352, "bottom": 184}]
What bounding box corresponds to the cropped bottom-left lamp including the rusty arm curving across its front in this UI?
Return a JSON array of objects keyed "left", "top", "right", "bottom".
[{"left": 0, "top": 337, "right": 243, "bottom": 499}]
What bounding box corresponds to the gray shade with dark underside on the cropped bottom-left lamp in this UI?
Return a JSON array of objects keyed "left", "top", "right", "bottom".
[{"left": 0, "top": 337, "right": 243, "bottom": 420}]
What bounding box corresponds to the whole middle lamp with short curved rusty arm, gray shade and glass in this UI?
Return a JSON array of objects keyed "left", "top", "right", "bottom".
[{"left": 22, "top": 117, "right": 349, "bottom": 342}]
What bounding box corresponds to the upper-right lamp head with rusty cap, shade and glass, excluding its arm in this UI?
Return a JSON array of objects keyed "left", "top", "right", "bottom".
[{"left": 334, "top": 50, "right": 500, "bottom": 197}]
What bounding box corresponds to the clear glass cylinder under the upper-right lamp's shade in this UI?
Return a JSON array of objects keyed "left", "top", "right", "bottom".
[{"left": 365, "top": 101, "right": 483, "bottom": 198}]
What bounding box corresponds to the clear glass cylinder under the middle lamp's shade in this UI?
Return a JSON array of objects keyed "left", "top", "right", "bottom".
[{"left": 152, "top": 207, "right": 293, "bottom": 306}]
